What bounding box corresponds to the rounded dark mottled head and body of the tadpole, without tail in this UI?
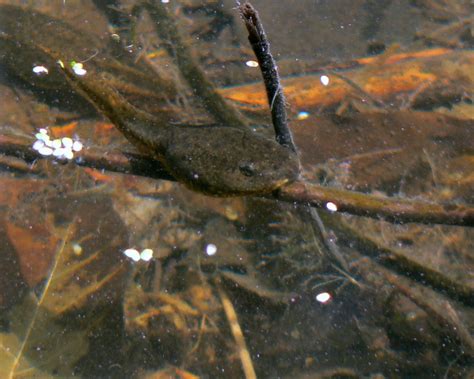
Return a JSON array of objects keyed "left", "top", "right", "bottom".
[{"left": 165, "top": 126, "right": 299, "bottom": 196}]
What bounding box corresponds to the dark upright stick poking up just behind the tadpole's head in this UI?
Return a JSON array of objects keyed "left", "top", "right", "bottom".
[{"left": 239, "top": 3, "right": 296, "bottom": 152}]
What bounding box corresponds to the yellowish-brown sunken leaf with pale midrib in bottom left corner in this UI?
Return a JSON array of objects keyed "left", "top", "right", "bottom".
[{"left": 0, "top": 215, "right": 126, "bottom": 378}]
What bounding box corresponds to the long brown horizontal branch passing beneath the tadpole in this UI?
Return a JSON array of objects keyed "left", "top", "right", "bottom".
[{"left": 0, "top": 135, "right": 474, "bottom": 227}]
